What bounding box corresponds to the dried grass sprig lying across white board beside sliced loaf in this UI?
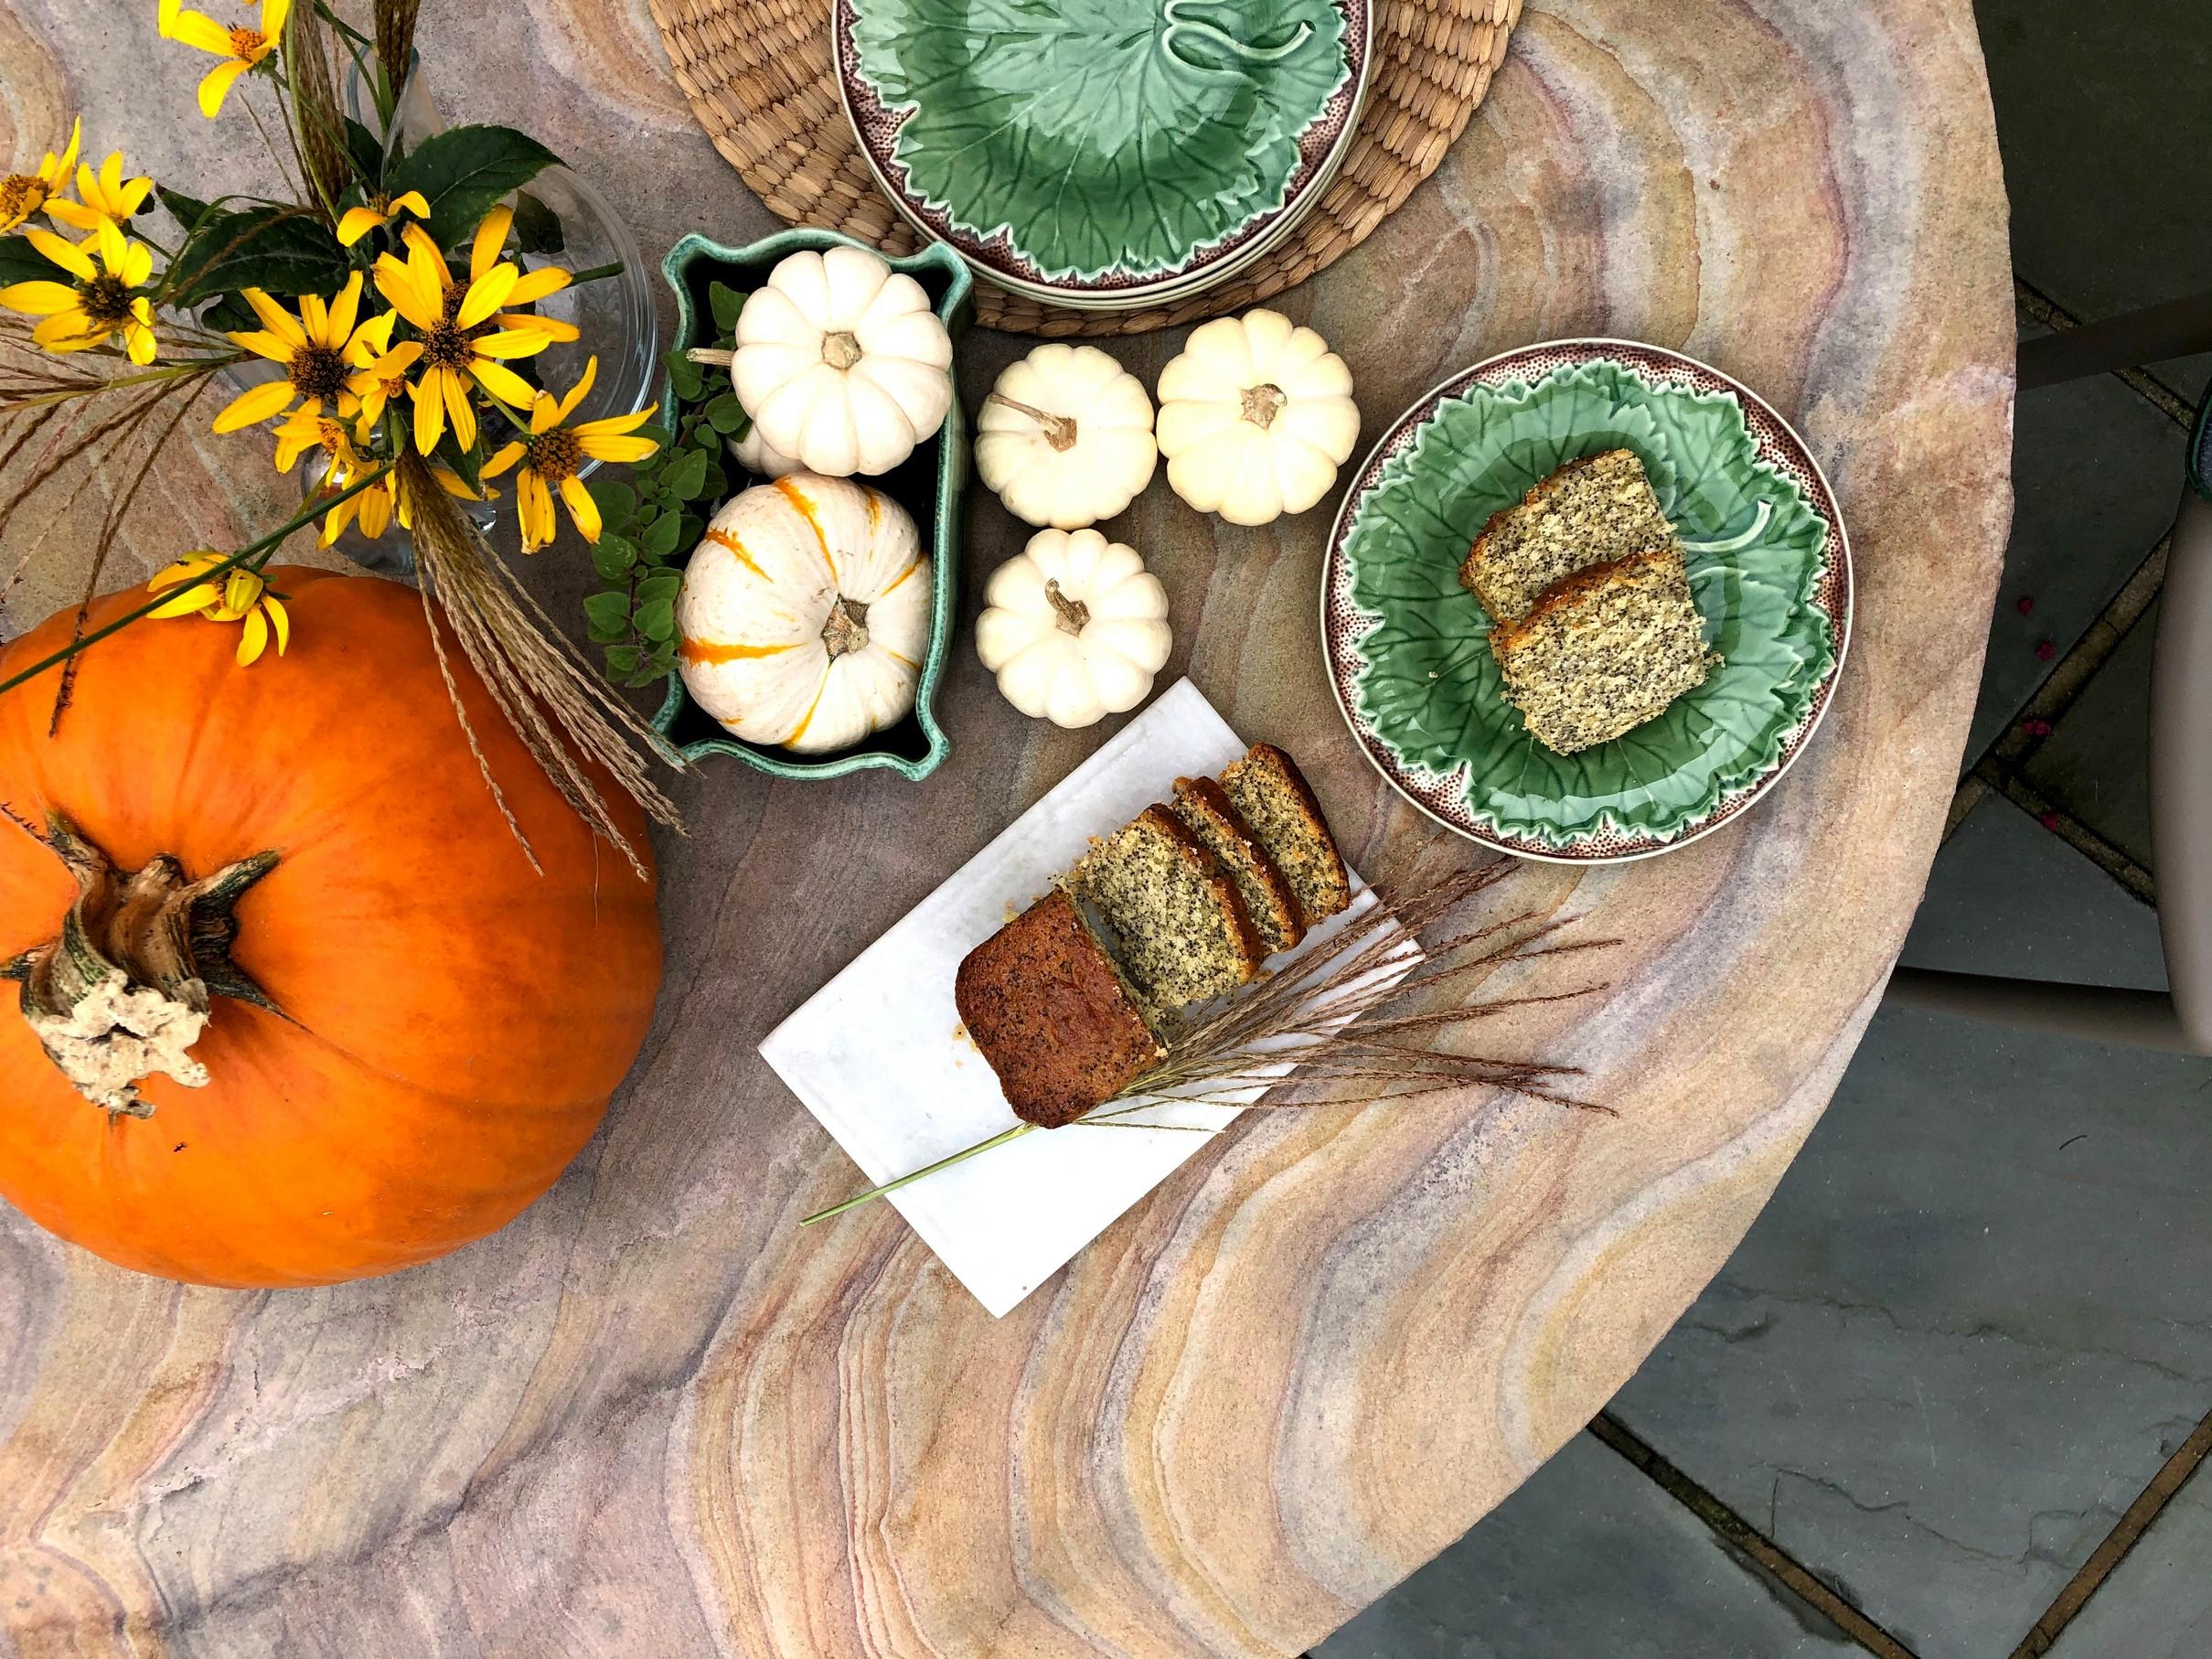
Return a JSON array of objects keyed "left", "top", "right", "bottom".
[{"left": 798, "top": 862, "right": 1619, "bottom": 1227}]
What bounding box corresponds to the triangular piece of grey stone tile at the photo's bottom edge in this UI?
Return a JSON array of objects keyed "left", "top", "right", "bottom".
[{"left": 1314, "top": 1433, "right": 1860, "bottom": 1659}]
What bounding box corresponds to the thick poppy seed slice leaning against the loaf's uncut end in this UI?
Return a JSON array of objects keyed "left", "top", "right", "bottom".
[{"left": 1066, "top": 805, "right": 1261, "bottom": 1031}]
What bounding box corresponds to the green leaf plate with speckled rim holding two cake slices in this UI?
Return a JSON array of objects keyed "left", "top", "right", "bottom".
[{"left": 1320, "top": 340, "right": 1852, "bottom": 862}]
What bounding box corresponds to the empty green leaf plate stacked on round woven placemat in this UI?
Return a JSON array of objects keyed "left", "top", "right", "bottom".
[{"left": 829, "top": 0, "right": 1373, "bottom": 310}]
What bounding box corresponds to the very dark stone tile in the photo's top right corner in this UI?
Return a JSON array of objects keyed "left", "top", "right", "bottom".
[{"left": 1975, "top": 0, "right": 2212, "bottom": 398}]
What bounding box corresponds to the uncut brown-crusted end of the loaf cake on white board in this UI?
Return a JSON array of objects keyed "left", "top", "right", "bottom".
[{"left": 954, "top": 887, "right": 1161, "bottom": 1129}]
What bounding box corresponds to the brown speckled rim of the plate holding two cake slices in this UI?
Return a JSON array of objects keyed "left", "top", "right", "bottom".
[{"left": 1320, "top": 338, "right": 1854, "bottom": 865}]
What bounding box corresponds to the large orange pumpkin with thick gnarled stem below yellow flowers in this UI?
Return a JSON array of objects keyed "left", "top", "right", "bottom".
[{"left": 0, "top": 569, "right": 661, "bottom": 1285}]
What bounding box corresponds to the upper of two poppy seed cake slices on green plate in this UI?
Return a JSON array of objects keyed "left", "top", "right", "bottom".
[{"left": 1460, "top": 449, "right": 1674, "bottom": 624}]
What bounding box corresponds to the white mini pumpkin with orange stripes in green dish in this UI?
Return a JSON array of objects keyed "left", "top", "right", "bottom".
[{"left": 677, "top": 474, "right": 931, "bottom": 755}]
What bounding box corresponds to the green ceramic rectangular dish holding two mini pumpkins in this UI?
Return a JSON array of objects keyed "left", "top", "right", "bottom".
[{"left": 653, "top": 228, "right": 976, "bottom": 781}]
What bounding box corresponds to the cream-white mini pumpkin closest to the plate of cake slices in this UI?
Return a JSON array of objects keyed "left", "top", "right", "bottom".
[{"left": 1159, "top": 310, "right": 1361, "bottom": 524}]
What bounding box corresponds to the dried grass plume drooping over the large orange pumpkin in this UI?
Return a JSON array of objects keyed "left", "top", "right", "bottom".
[{"left": 398, "top": 449, "right": 683, "bottom": 876}]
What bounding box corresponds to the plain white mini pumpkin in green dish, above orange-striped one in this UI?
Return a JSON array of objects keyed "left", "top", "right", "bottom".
[{"left": 730, "top": 248, "right": 954, "bottom": 477}]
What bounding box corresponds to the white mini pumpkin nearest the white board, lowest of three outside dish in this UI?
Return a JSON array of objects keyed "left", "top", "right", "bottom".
[{"left": 976, "top": 530, "right": 1174, "bottom": 728}]
